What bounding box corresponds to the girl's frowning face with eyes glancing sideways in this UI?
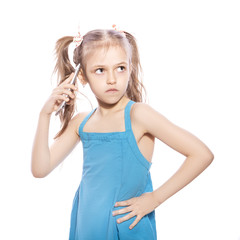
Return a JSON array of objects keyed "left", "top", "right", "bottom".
[{"left": 85, "top": 46, "right": 130, "bottom": 104}]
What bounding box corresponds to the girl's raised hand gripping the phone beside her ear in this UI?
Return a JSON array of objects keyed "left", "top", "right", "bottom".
[{"left": 41, "top": 73, "right": 77, "bottom": 115}]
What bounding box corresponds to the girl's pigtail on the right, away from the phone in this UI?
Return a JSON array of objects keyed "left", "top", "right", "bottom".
[{"left": 124, "top": 32, "right": 146, "bottom": 102}]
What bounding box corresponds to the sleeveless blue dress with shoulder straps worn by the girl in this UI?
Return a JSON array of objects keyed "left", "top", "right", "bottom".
[{"left": 69, "top": 100, "right": 157, "bottom": 240}]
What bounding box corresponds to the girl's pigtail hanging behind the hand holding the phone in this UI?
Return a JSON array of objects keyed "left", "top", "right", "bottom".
[{"left": 53, "top": 36, "right": 76, "bottom": 139}]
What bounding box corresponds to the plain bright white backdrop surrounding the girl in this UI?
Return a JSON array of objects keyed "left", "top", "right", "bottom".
[{"left": 0, "top": 0, "right": 240, "bottom": 240}]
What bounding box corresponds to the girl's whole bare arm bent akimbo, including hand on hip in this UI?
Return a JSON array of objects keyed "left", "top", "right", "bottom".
[{"left": 113, "top": 103, "right": 214, "bottom": 229}]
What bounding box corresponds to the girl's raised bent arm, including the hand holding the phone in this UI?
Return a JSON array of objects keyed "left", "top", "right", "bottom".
[{"left": 31, "top": 74, "right": 82, "bottom": 178}]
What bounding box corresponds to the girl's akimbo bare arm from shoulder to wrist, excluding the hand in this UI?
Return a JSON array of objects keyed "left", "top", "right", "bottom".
[{"left": 134, "top": 103, "right": 214, "bottom": 205}]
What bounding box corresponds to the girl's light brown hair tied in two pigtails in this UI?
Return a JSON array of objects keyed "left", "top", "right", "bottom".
[{"left": 54, "top": 29, "right": 146, "bottom": 138}]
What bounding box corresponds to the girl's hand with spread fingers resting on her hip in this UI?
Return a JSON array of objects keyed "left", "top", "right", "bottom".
[{"left": 112, "top": 192, "right": 160, "bottom": 229}]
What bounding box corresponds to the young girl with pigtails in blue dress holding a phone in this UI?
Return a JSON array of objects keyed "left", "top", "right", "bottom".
[{"left": 32, "top": 26, "right": 214, "bottom": 240}]
